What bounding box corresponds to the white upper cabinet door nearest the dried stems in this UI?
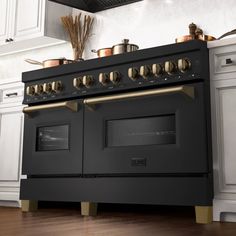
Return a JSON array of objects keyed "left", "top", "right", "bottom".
[{"left": 11, "top": 0, "right": 45, "bottom": 41}]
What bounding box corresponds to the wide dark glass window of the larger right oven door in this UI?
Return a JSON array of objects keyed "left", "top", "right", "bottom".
[{"left": 106, "top": 114, "right": 176, "bottom": 147}]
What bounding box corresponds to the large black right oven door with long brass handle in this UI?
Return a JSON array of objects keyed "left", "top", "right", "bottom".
[{"left": 84, "top": 83, "right": 208, "bottom": 175}]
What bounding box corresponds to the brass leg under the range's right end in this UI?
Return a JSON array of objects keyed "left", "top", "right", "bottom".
[{"left": 195, "top": 206, "right": 213, "bottom": 224}]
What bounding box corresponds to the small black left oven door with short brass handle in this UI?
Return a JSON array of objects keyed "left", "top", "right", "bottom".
[{"left": 22, "top": 100, "right": 83, "bottom": 175}]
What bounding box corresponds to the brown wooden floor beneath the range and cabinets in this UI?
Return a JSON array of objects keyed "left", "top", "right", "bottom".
[{"left": 0, "top": 204, "right": 236, "bottom": 236}]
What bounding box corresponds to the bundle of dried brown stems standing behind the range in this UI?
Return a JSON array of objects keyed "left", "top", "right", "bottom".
[{"left": 61, "top": 13, "right": 94, "bottom": 60}]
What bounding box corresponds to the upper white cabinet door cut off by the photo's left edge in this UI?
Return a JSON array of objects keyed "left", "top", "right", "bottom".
[{"left": 0, "top": 0, "right": 11, "bottom": 44}]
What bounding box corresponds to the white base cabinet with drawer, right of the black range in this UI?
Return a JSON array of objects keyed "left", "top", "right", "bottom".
[{"left": 210, "top": 40, "right": 236, "bottom": 222}]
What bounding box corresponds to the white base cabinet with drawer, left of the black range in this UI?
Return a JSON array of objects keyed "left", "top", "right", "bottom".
[{"left": 0, "top": 81, "right": 24, "bottom": 206}]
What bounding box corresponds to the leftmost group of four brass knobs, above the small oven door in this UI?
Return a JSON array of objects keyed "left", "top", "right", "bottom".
[{"left": 26, "top": 81, "right": 62, "bottom": 96}]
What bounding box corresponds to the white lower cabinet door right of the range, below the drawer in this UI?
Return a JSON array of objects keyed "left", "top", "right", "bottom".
[{"left": 212, "top": 79, "right": 236, "bottom": 196}]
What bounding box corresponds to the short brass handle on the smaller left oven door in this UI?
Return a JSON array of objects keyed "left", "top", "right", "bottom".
[{"left": 23, "top": 101, "right": 78, "bottom": 114}]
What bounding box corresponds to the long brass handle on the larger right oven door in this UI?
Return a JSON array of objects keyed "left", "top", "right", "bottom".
[{"left": 84, "top": 85, "right": 194, "bottom": 106}]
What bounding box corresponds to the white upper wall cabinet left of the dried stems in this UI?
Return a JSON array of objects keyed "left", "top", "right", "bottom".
[{"left": 0, "top": 0, "right": 72, "bottom": 55}]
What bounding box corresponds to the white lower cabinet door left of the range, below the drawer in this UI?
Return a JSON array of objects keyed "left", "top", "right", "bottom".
[{"left": 0, "top": 107, "right": 23, "bottom": 182}]
